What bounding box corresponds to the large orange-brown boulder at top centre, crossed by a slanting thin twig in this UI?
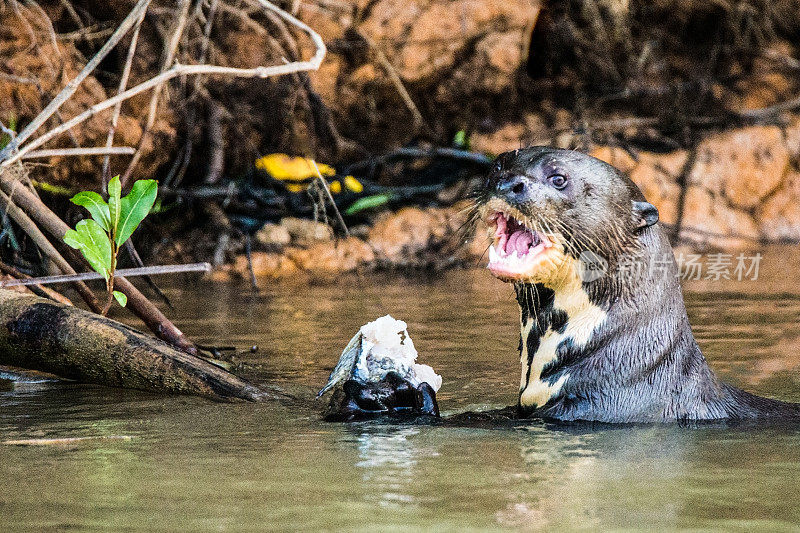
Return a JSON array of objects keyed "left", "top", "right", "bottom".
[{"left": 310, "top": 0, "right": 539, "bottom": 152}]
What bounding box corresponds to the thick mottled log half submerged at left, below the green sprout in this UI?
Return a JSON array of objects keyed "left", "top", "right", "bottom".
[{"left": 0, "top": 289, "right": 266, "bottom": 401}]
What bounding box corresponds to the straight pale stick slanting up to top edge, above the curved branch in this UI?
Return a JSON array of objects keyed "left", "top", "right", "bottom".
[{"left": 0, "top": 0, "right": 150, "bottom": 164}]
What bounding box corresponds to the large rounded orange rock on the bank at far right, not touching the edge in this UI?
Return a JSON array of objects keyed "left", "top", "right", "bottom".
[{"left": 688, "top": 126, "right": 789, "bottom": 209}]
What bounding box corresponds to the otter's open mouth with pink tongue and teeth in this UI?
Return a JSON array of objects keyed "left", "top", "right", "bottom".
[{"left": 486, "top": 211, "right": 553, "bottom": 280}]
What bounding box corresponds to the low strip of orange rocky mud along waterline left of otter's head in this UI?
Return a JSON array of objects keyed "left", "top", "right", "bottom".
[{"left": 210, "top": 202, "right": 489, "bottom": 282}]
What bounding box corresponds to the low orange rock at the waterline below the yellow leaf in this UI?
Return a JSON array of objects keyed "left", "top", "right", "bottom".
[{"left": 286, "top": 237, "right": 375, "bottom": 274}]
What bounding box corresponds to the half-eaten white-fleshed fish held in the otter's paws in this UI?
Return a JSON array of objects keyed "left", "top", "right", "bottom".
[{"left": 317, "top": 315, "right": 442, "bottom": 398}]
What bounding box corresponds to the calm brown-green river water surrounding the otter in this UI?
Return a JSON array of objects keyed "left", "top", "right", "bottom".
[{"left": 0, "top": 249, "right": 800, "bottom": 531}]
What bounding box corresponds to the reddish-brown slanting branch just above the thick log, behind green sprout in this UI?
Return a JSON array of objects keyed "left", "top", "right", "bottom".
[{"left": 0, "top": 172, "right": 197, "bottom": 355}]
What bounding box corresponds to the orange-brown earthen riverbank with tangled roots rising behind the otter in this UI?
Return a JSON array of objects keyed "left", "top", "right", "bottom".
[{"left": 0, "top": 0, "right": 800, "bottom": 277}]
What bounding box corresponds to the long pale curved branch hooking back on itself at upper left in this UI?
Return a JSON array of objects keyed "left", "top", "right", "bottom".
[{"left": 0, "top": 0, "right": 327, "bottom": 167}]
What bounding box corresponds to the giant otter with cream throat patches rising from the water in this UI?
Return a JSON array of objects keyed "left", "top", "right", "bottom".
[{"left": 328, "top": 147, "right": 800, "bottom": 423}]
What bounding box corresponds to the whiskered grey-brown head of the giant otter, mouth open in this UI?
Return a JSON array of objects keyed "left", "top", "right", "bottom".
[{"left": 478, "top": 147, "right": 658, "bottom": 288}]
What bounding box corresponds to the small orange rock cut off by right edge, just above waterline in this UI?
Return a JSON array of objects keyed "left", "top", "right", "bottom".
[{"left": 756, "top": 170, "right": 800, "bottom": 242}]
